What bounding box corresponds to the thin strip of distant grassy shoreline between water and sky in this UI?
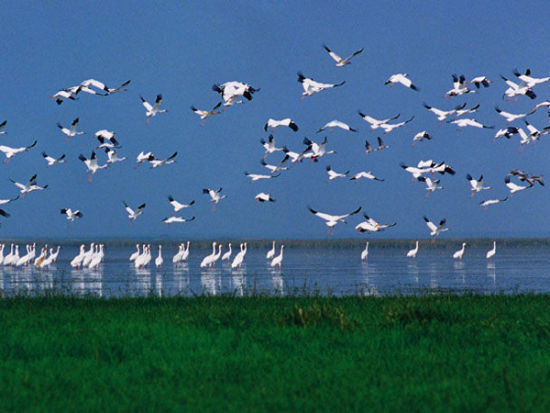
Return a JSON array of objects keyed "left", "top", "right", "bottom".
[{"left": 0, "top": 237, "right": 550, "bottom": 249}]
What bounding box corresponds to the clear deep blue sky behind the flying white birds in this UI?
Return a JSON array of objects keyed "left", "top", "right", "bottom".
[{"left": 0, "top": 1, "right": 550, "bottom": 239}]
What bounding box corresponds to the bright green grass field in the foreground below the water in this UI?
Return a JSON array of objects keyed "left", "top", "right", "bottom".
[{"left": 0, "top": 295, "right": 550, "bottom": 412}]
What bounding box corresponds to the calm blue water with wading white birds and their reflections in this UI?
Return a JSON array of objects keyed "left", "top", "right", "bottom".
[{"left": 0, "top": 245, "right": 550, "bottom": 297}]
